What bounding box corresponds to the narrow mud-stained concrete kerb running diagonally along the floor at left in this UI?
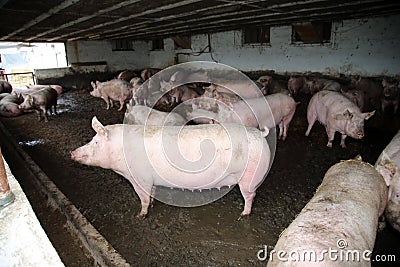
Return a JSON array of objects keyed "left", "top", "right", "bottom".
[{"left": 0, "top": 122, "right": 130, "bottom": 267}]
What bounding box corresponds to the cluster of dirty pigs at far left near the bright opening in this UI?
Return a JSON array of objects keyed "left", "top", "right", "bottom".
[{"left": 0, "top": 80, "right": 62, "bottom": 122}]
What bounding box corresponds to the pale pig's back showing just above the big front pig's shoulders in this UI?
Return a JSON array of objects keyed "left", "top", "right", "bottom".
[{"left": 124, "top": 105, "right": 186, "bottom": 126}]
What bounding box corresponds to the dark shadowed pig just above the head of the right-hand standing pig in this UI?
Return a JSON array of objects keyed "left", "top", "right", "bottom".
[{"left": 351, "top": 77, "right": 383, "bottom": 111}]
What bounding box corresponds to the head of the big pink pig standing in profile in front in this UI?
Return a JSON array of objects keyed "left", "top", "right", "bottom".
[{"left": 71, "top": 117, "right": 112, "bottom": 169}]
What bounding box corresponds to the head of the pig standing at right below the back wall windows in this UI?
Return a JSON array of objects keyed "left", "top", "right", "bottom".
[{"left": 335, "top": 109, "right": 375, "bottom": 139}]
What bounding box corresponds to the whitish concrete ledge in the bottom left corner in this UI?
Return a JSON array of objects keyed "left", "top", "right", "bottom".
[{"left": 0, "top": 160, "right": 64, "bottom": 267}]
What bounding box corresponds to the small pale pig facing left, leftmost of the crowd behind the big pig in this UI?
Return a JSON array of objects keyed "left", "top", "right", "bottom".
[{"left": 90, "top": 79, "right": 132, "bottom": 111}]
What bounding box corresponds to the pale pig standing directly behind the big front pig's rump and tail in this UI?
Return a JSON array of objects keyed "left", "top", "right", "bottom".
[{"left": 187, "top": 93, "right": 297, "bottom": 140}]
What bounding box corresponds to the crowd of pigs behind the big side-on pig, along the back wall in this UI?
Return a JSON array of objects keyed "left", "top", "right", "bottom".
[{"left": 91, "top": 69, "right": 400, "bottom": 148}]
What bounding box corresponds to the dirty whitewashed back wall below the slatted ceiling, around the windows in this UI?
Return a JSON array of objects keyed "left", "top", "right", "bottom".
[{"left": 67, "top": 15, "right": 400, "bottom": 76}]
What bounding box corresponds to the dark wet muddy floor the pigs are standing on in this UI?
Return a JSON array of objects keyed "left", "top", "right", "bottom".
[{"left": 0, "top": 90, "right": 400, "bottom": 266}]
